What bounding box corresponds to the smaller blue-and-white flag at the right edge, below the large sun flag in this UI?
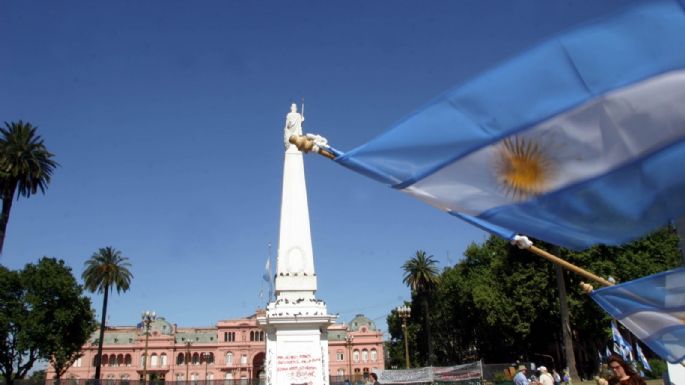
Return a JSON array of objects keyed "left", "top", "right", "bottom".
[{"left": 591, "top": 268, "right": 685, "bottom": 363}]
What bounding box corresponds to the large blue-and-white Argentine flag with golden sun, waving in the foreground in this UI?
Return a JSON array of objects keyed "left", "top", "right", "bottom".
[{"left": 333, "top": 1, "right": 685, "bottom": 249}]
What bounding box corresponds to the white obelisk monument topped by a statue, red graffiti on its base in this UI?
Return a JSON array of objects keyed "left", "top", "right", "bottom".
[{"left": 257, "top": 103, "right": 336, "bottom": 385}]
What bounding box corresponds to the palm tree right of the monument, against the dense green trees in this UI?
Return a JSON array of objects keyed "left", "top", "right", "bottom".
[{"left": 402, "top": 250, "right": 438, "bottom": 365}]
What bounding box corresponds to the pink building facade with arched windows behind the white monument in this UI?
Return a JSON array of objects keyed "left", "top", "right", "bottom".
[{"left": 47, "top": 312, "right": 385, "bottom": 383}]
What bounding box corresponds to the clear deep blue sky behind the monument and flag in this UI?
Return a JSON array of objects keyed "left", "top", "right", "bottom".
[{"left": 0, "top": 0, "right": 644, "bottom": 329}]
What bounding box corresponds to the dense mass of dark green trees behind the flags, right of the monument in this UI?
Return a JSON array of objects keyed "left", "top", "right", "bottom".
[{"left": 388, "top": 228, "right": 681, "bottom": 376}]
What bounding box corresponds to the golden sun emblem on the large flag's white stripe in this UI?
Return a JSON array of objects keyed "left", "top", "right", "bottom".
[{"left": 495, "top": 136, "right": 554, "bottom": 200}]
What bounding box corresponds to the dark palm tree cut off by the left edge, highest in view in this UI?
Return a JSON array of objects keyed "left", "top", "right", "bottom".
[{"left": 0, "top": 120, "right": 58, "bottom": 253}]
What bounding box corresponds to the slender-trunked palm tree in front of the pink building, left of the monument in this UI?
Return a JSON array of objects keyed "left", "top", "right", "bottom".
[{"left": 81, "top": 246, "right": 133, "bottom": 380}]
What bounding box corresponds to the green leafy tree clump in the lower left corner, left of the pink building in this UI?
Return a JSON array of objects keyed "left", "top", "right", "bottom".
[{"left": 0, "top": 257, "right": 95, "bottom": 385}]
